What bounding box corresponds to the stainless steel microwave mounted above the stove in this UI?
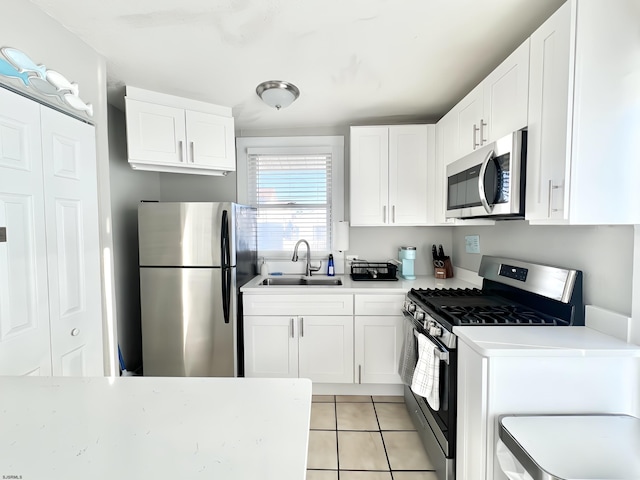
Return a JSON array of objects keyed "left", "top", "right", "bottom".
[{"left": 446, "top": 130, "right": 527, "bottom": 218}]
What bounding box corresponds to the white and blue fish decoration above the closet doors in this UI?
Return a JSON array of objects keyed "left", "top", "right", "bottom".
[{"left": 0, "top": 47, "right": 93, "bottom": 117}]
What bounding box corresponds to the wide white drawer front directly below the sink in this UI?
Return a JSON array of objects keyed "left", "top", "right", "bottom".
[{"left": 243, "top": 295, "right": 353, "bottom": 315}]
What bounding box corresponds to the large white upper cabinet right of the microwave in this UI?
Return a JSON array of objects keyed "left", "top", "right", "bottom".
[{"left": 526, "top": 0, "right": 640, "bottom": 224}]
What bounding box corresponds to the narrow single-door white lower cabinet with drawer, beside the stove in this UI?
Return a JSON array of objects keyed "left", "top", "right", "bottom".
[{"left": 354, "top": 294, "right": 404, "bottom": 384}]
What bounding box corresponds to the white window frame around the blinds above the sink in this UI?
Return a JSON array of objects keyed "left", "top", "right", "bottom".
[{"left": 236, "top": 135, "right": 345, "bottom": 261}]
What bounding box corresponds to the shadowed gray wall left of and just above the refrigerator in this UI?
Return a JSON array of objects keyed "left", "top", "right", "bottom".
[{"left": 109, "top": 107, "right": 160, "bottom": 371}]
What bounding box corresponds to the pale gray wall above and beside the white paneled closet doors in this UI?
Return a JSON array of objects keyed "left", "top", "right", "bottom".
[{"left": 0, "top": 0, "right": 117, "bottom": 372}]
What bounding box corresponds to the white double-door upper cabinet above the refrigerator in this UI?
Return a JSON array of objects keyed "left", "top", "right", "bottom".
[{"left": 125, "top": 87, "right": 236, "bottom": 175}]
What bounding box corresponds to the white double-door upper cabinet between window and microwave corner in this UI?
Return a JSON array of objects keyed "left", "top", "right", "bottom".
[{"left": 350, "top": 125, "right": 435, "bottom": 226}]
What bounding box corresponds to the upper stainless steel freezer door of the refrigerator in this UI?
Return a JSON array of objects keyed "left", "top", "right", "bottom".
[{"left": 138, "top": 202, "right": 236, "bottom": 267}]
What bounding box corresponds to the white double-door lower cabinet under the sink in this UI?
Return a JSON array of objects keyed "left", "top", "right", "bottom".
[{"left": 243, "top": 294, "right": 353, "bottom": 383}]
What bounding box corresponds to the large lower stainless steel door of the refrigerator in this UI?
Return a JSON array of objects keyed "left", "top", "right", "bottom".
[{"left": 140, "top": 268, "right": 237, "bottom": 377}]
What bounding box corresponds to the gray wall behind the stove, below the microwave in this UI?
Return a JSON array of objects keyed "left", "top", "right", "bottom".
[{"left": 453, "top": 221, "right": 634, "bottom": 316}]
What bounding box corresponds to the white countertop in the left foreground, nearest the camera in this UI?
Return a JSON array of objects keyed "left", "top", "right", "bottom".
[{"left": 0, "top": 377, "right": 311, "bottom": 480}]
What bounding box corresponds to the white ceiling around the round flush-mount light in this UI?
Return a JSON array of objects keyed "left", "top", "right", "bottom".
[{"left": 31, "top": 0, "right": 564, "bottom": 130}]
